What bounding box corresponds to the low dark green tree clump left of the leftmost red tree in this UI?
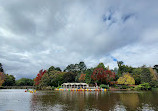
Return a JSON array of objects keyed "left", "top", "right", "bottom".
[{"left": 16, "top": 78, "right": 33, "bottom": 86}]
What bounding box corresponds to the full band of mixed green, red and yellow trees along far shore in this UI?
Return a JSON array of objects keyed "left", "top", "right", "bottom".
[{"left": 0, "top": 61, "right": 158, "bottom": 89}]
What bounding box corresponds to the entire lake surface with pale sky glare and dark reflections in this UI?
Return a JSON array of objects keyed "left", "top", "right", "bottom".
[{"left": 0, "top": 89, "right": 158, "bottom": 111}]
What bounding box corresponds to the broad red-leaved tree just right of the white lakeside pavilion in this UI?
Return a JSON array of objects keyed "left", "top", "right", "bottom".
[{"left": 91, "top": 68, "right": 115, "bottom": 84}]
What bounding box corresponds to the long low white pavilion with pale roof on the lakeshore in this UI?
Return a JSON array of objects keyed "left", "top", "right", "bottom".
[{"left": 61, "top": 83, "right": 89, "bottom": 88}]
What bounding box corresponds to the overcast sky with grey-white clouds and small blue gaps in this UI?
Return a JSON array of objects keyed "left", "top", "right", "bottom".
[{"left": 0, "top": 0, "right": 158, "bottom": 78}]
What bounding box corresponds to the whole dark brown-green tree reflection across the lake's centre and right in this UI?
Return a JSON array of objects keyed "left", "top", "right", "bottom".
[{"left": 31, "top": 91, "right": 158, "bottom": 111}]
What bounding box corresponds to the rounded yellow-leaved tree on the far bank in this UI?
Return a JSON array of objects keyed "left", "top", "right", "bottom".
[{"left": 117, "top": 73, "right": 135, "bottom": 85}]
